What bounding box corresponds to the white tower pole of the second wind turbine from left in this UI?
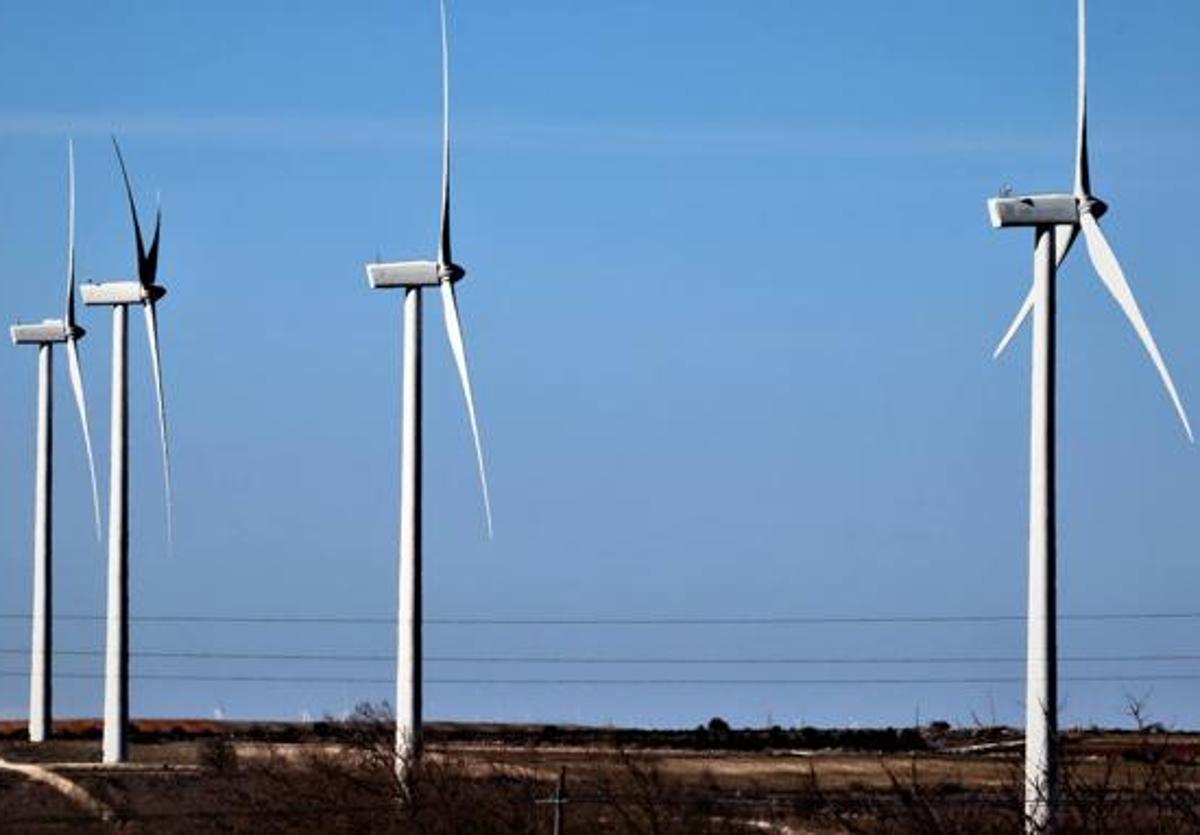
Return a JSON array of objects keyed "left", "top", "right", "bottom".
[{"left": 103, "top": 305, "right": 130, "bottom": 763}]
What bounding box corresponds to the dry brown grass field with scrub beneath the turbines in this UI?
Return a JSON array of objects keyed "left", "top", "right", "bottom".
[{"left": 0, "top": 710, "right": 1200, "bottom": 835}]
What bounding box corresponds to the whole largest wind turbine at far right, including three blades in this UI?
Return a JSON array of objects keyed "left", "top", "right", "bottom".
[{"left": 988, "top": 0, "right": 1193, "bottom": 833}]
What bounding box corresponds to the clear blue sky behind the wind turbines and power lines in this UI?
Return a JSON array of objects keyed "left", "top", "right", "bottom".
[{"left": 0, "top": 0, "right": 1200, "bottom": 726}]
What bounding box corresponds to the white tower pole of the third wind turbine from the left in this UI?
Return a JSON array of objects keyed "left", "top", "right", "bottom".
[{"left": 396, "top": 287, "right": 421, "bottom": 786}]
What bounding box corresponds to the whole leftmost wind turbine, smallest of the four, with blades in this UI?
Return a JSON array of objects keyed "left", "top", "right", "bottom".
[{"left": 12, "top": 143, "right": 100, "bottom": 743}]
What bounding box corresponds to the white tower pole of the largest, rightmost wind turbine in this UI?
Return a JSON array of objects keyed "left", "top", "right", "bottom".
[{"left": 1025, "top": 226, "right": 1058, "bottom": 835}]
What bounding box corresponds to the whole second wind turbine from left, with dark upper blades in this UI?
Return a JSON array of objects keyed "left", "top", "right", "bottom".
[{"left": 82, "top": 138, "right": 170, "bottom": 763}]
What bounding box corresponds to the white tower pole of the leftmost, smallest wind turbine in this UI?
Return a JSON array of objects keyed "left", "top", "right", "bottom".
[{"left": 29, "top": 342, "right": 54, "bottom": 743}]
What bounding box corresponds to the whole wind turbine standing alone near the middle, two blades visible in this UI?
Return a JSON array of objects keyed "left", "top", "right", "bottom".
[{"left": 366, "top": 0, "right": 492, "bottom": 782}]
